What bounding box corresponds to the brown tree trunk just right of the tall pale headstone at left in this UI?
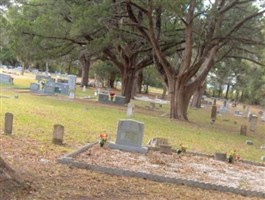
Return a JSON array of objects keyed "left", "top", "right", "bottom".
[{"left": 79, "top": 53, "right": 91, "bottom": 87}]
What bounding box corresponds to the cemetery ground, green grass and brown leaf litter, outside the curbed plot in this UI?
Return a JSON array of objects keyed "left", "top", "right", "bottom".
[{"left": 0, "top": 79, "right": 265, "bottom": 200}]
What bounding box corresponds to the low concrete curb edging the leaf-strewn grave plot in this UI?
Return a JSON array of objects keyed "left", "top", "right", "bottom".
[{"left": 57, "top": 142, "right": 265, "bottom": 198}]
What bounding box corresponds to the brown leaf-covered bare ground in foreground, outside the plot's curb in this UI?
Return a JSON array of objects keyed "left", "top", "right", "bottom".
[{"left": 0, "top": 135, "right": 260, "bottom": 200}]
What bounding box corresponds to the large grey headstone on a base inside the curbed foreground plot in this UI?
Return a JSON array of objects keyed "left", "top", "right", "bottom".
[{"left": 109, "top": 120, "right": 148, "bottom": 153}]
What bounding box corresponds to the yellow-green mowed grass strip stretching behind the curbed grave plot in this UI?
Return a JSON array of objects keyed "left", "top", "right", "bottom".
[{"left": 0, "top": 74, "right": 265, "bottom": 161}]
